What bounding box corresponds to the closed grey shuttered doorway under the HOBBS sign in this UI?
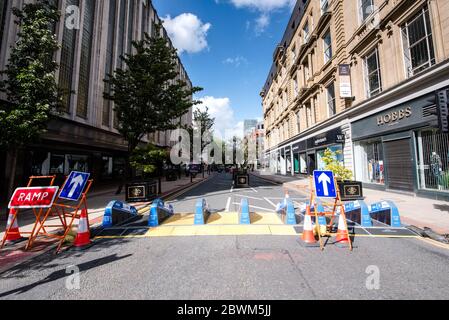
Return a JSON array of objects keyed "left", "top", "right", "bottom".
[{"left": 384, "top": 138, "right": 414, "bottom": 192}]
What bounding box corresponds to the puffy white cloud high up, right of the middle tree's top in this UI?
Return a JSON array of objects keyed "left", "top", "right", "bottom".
[{"left": 163, "top": 13, "right": 212, "bottom": 54}]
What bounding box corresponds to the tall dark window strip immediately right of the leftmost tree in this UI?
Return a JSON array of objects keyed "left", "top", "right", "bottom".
[{"left": 59, "top": 0, "right": 79, "bottom": 113}]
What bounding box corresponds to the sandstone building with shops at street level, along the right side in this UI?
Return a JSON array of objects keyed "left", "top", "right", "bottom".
[{"left": 261, "top": 0, "right": 449, "bottom": 198}]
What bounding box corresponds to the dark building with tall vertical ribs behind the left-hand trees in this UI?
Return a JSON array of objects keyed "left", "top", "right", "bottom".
[{"left": 0, "top": 0, "right": 192, "bottom": 190}]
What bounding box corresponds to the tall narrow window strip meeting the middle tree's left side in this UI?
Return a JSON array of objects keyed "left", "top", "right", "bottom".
[{"left": 102, "top": 0, "right": 117, "bottom": 127}]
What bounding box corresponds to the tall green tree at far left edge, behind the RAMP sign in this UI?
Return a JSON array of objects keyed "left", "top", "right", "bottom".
[{"left": 0, "top": 0, "right": 60, "bottom": 198}]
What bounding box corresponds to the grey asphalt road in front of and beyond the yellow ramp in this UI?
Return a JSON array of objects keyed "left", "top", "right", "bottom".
[{"left": 0, "top": 174, "right": 449, "bottom": 299}]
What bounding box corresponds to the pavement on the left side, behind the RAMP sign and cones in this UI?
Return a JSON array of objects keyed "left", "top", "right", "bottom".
[{"left": 0, "top": 173, "right": 212, "bottom": 239}]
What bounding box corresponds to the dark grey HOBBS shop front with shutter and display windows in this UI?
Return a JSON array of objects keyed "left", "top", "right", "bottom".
[{"left": 352, "top": 89, "right": 449, "bottom": 198}]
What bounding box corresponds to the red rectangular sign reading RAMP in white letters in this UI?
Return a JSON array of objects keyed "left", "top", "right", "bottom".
[{"left": 8, "top": 187, "right": 59, "bottom": 209}]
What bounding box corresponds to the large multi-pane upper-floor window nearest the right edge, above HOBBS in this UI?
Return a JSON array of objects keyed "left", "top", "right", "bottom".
[{"left": 402, "top": 7, "right": 435, "bottom": 77}]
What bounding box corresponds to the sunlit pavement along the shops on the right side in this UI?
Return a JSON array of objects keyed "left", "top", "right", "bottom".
[{"left": 253, "top": 172, "right": 449, "bottom": 234}]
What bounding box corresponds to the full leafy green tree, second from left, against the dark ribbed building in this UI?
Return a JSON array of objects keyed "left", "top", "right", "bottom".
[{"left": 104, "top": 25, "right": 202, "bottom": 190}]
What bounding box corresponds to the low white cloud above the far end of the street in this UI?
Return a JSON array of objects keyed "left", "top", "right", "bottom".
[{"left": 197, "top": 96, "right": 243, "bottom": 139}]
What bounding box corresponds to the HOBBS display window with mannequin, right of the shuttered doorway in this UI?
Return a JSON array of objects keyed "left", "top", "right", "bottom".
[{"left": 417, "top": 130, "right": 449, "bottom": 192}]
